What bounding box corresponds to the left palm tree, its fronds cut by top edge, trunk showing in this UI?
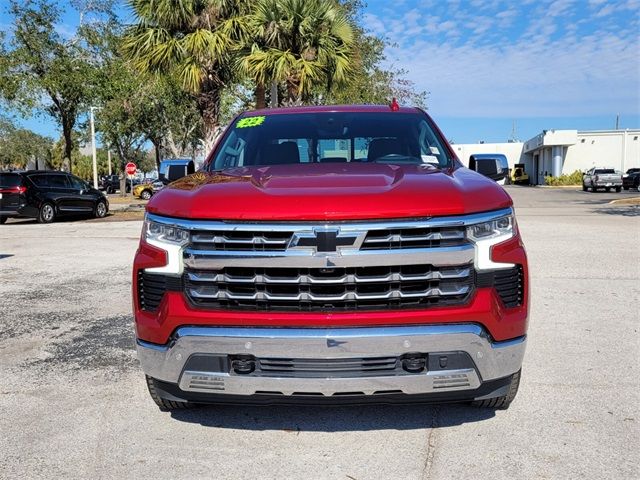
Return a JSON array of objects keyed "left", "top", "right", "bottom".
[{"left": 123, "top": 0, "right": 252, "bottom": 150}]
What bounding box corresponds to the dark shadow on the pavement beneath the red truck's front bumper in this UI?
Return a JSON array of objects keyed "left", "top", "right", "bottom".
[{"left": 171, "top": 404, "right": 495, "bottom": 434}]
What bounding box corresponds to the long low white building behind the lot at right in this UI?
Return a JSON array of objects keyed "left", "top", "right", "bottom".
[{"left": 452, "top": 129, "right": 640, "bottom": 185}]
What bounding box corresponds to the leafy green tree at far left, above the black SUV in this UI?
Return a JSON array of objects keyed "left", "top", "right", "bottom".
[{"left": 0, "top": 0, "right": 93, "bottom": 169}]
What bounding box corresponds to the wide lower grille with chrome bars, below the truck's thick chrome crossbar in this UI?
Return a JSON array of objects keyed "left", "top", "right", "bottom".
[{"left": 185, "top": 265, "right": 474, "bottom": 311}]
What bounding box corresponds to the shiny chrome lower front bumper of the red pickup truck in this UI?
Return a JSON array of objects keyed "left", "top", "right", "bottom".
[{"left": 137, "top": 324, "right": 526, "bottom": 396}]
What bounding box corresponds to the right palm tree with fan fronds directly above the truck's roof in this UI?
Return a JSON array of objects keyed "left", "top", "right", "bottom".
[{"left": 240, "top": 0, "right": 354, "bottom": 107}]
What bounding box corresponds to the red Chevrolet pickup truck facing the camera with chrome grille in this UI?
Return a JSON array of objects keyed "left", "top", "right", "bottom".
[{"left": 133, "top": 105, "right": 528, "bottom": 410}]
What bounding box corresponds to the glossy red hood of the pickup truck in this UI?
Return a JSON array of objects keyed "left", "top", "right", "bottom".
[{"left": 147, "top": 163, "right": 512, "bottom": 221}]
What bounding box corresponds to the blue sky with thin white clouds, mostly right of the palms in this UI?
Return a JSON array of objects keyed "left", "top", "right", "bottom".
[{"left": 0, "top": 0, "right": 640, "bottom": 143}]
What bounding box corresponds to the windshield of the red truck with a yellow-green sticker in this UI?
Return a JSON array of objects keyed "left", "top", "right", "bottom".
[{"left": 210, "top": 112, "right": 451, "bottom": 170}]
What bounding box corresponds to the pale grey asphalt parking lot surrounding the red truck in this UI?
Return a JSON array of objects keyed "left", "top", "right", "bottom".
[{"left": 0, "top": 187, "right": 640, "bottom": 480}]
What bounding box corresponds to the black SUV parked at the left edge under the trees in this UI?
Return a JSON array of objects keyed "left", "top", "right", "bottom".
[{"left": 0, "top": 170, "right": 109, "bottom": 224}]
